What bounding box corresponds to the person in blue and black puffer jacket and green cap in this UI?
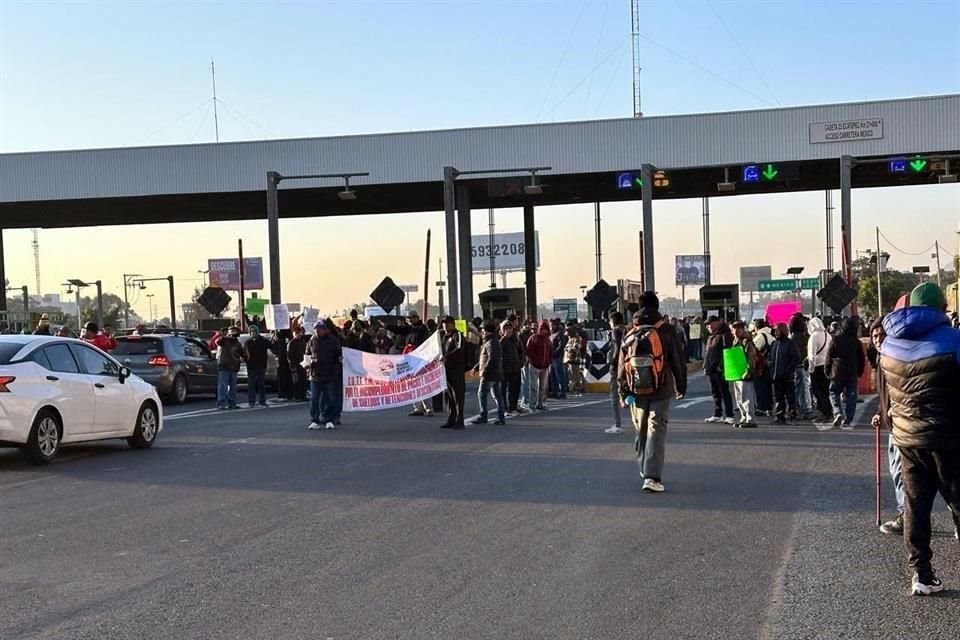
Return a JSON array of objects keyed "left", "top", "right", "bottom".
[{"left": 880, "top": 283, "right": 960, "bottom": 595}]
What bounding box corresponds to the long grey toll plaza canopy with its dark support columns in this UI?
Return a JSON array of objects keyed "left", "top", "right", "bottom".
[{"left": 0, "top": 94, "right": 960, "bottom": 317}]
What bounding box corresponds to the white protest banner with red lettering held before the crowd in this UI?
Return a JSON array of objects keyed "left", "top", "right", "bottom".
[{"left": 343, "top": 333, "right": 447, "bottom": 411}]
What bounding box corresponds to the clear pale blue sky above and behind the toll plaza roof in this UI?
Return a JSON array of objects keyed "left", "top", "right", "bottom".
[{"left": 0, "top": 0, "right": 960, "bottom": 316}]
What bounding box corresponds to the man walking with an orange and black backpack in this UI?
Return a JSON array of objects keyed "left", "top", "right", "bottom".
[{"left": 617, "top": 291, "right": 687, "bottom": 493}]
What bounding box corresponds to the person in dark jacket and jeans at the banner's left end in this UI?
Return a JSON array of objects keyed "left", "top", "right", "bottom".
[{"left": 307, "top": 320, "right": 343, "bottom": 431}]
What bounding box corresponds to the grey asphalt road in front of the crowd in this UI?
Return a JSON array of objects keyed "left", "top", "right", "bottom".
[{"left": 0, "top": 378, "right": 960, "bottom": 640}]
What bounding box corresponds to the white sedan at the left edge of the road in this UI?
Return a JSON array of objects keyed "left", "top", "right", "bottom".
[{"left": 0, "top": 335, "right": 163, "bottom": 464}]
